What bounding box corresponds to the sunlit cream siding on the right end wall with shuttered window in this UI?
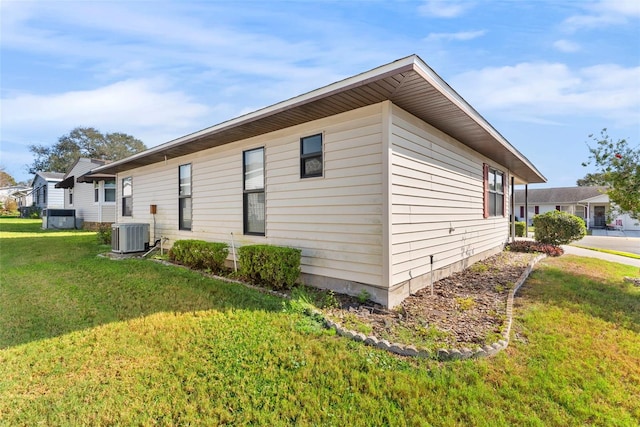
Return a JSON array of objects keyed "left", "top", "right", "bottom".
[{"left": 390, "top": 106, "right": 508, "bottom": 285}]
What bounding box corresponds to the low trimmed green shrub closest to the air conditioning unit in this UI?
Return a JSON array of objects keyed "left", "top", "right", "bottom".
[{"left": 169, "top": 240, "right": 229, "bottom": 272}]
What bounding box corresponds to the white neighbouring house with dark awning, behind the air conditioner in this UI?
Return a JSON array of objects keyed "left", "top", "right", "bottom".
[{"left": 55, "top": 157, "right": 116, "bottom": 230}]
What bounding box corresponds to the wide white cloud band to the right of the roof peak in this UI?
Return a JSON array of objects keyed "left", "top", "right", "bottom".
[{"left": 451, "top": 62, "right": 640, "bottom": 126}]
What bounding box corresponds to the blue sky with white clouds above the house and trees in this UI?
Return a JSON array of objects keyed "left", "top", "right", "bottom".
[{"left": 0, "top": 0, "right": 640, "bottom": 187}]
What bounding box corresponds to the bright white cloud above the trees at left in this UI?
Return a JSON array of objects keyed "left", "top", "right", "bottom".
[{"left": 2, "top": 79, "right": 212, "bottom": 146}]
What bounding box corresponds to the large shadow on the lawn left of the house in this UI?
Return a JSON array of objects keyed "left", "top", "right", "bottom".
[{"left": 0, "top": 229, "right": 282, "bottom": 348}]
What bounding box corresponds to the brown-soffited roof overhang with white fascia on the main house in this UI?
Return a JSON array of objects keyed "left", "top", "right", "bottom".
[{"left": 92, "top": 55, "right": 546, "bottom": 184}]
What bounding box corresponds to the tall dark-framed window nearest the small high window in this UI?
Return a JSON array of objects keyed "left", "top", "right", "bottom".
[{"left": 242, "top": 148, "right": 265, "bottom": 236}]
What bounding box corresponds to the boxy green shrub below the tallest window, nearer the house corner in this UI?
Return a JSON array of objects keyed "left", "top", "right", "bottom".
[{"left": 238, "top": 245, "right": 300, "bottom": 290}]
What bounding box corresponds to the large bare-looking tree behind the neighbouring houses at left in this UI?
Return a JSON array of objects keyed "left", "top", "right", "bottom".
[{"left": 29, "top": 127, "right": 147, "bottom": 173}]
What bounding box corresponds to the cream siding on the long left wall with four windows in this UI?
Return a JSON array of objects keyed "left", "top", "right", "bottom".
[{"left": 117, "top": 104, "right": 387, "bottom": 286}]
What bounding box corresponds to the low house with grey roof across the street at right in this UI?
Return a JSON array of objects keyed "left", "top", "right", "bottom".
[{"left": 515, "top": 186, "right": 640, "bottom": 230}]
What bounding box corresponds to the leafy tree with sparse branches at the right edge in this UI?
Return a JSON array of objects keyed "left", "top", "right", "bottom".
[{"left": 582, "top": 128, "right": 640, "bottom": 220}]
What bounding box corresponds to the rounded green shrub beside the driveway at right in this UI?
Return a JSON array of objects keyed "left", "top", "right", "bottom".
[{"left": 533, "top": 211, "right": 587, "bottom": 245}]
